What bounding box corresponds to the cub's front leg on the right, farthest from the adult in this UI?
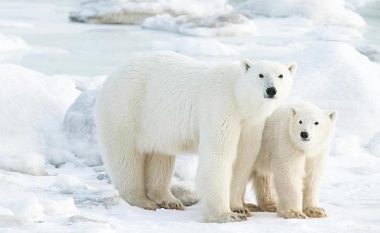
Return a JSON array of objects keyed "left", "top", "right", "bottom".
[{"left": 303, "top": 155, "right": 327, "bottom": 218}]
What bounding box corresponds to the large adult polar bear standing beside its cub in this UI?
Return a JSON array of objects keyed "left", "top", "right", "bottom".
[{"left": 96, "top": 52, "right": 296, "bottom": 222}]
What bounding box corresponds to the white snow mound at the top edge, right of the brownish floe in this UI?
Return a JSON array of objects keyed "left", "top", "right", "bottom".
[{"left": 238, "top": 0, "right": 366, "bottom": 28}]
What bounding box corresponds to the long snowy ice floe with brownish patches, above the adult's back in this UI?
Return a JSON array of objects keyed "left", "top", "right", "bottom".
[{"left": 69, "top": 0, "right": 256, "bottom": 36}]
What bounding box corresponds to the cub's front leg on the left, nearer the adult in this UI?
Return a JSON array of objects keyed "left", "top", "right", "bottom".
[{"left": 272, "top": 152, "right": 306, "bottom": 218}]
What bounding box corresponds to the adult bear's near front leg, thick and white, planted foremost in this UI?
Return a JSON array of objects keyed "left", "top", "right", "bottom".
[{"left": 197, "top": 116, "right": 246, "bottom": 223}]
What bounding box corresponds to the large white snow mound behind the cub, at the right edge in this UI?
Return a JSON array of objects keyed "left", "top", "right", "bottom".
[{"left": 292, "top": 42, "right": 380, "bottom": 144}]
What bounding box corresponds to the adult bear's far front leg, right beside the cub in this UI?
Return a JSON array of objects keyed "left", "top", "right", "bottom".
[{"left": 231, "top": 122, "right": 264, "bottom": 216}]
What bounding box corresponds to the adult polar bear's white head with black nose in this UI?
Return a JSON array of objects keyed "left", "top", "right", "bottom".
[{"left": 242, "top": 60, "right": 297, "bottom": 102}]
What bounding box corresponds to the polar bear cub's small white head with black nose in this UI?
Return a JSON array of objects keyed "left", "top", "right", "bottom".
[{"left": 289, "top": 103, "right": 336, "bottom": 156}]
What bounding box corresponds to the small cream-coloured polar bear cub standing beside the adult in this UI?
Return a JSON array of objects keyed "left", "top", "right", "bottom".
[{"left": 250, "top": 102, "right": 336, "bottom": 218}]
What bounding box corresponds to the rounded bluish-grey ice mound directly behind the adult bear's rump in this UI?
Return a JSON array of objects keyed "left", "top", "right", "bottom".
[{"left": 63, "top": 90, "right": 102, "bottom": 166}]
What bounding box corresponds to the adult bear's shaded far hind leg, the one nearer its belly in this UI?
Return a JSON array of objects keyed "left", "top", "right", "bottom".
[{"left": 145, "top": 154, "right": 185, "bottom": 210}]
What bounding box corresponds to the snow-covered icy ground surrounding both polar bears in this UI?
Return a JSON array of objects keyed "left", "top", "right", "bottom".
[{"left": 0, "top": 0, "right": 380, "bottom": 233}]
